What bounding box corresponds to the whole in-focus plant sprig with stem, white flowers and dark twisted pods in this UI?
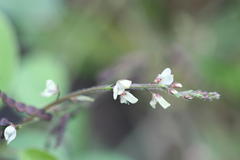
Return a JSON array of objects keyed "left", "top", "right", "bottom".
[{"left": 0, "top": 68, "right": 220, "bottom": 145}]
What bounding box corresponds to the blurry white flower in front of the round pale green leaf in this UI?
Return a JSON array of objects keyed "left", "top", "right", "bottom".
[{"left": 41, "top": 80, "right": 59, "bottom": 97}]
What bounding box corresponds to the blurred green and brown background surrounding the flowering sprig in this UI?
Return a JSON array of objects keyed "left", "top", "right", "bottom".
[{"left": 0, "top": 0, "right": 240, "bottom": 160}]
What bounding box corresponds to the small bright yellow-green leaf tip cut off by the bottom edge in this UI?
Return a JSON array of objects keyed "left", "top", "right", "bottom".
[{"left": 21, "top": 149, "right": 57, "bottom": 160}]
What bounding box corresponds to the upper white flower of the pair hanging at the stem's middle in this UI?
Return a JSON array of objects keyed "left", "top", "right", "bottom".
[{"left": 113, "top": 79, "right": 132, "bottom": 100}]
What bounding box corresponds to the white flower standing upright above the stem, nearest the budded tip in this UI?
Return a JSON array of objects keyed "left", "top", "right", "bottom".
[{"left": 154, "top": 68, "right": 173, "bottom": 85}]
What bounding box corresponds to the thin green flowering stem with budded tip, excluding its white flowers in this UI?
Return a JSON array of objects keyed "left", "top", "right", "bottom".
[{"left": 16, "top": 83, "right": 219, "bottom": 128}]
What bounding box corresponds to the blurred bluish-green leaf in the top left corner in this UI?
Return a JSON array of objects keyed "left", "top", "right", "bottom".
[{"left": 0, "top": 0, "right": 64, "bottom": 45}]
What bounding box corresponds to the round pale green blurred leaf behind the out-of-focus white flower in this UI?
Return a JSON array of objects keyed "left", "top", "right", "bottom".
[{"left": 14, "top": 52, "right": 69, "bottom": 107}]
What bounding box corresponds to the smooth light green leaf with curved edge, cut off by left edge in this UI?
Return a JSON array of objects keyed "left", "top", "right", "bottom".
[{"left": 0, "top": 12, "right": 18, "bottom": 91}]
